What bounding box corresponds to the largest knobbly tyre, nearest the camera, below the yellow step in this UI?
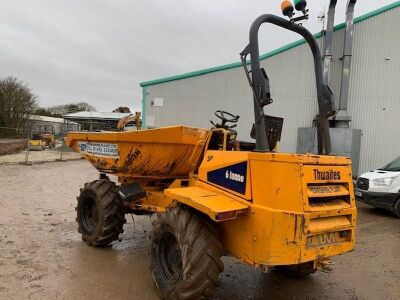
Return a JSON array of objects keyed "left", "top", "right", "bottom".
[{"left": 150, "top": 206, "right": 224, "bottom": 299}]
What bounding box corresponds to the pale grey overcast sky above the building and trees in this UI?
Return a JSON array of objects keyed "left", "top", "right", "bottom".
[{"left": 0, "top": 0, "right": 394, "bottom": 111}]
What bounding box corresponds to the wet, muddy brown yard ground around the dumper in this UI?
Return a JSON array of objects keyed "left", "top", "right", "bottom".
[{"left": 0, "top": 160, "right": 400, "bottom": 300}]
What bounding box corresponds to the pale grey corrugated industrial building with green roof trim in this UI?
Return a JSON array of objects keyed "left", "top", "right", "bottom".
[{"left": 140, "top": 1, "right": 400, "bottom": 173}]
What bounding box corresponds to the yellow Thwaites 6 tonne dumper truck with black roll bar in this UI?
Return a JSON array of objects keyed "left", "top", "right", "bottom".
[{"left": 66, "top": 1, "right": 356, "bottom": 299}]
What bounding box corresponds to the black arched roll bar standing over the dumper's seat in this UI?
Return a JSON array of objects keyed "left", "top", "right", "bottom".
[{"left": 240, "top": 14, "right": 335, "bottom": 154}]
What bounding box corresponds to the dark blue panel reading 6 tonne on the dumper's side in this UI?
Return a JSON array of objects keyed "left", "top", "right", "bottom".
[{"left": 207, "top": 162, "right": 247, "bottom": 195}]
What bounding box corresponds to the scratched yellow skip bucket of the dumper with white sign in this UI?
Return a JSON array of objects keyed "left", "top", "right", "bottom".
[{"left": 66, "top": 126, "right": 208, "bottom": 179}]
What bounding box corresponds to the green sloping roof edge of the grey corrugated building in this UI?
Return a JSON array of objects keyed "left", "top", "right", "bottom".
[{"left": 139, "top": 1, "right": 400, "bottom": 87}]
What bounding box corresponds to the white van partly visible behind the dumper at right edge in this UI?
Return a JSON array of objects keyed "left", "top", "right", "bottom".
[{"left": 355, "top": 156, "right": 400, "bottom": 218}]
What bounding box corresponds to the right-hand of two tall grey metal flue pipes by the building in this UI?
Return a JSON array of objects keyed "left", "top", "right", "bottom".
[{"left": 334, "top": 0, "right": 357, "bottom": 128}]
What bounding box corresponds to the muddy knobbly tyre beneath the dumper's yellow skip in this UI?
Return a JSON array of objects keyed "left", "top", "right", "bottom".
[{"left": 76, "top": 179, "right": 126, "bottom": 246}]
